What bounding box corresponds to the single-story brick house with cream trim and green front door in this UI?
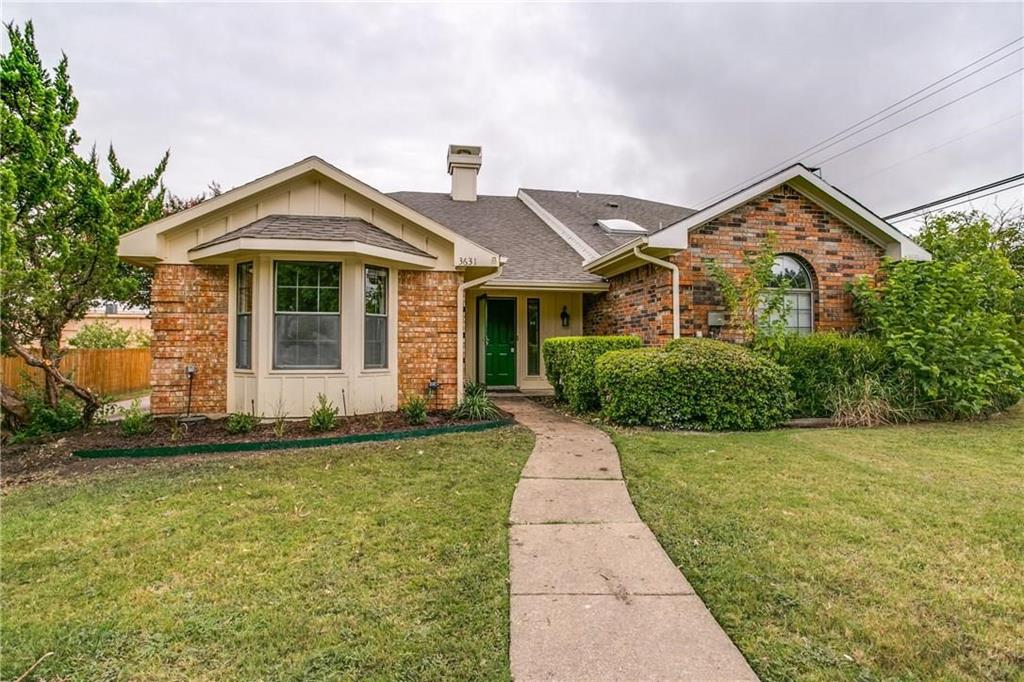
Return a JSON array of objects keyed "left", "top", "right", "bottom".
[{"left": 120, "top": 145, "right": 929, "bottom": 417}]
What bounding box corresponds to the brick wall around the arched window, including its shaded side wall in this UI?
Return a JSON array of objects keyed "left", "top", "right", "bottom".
[{"left": 584, "top": 185, "right": 885, "bottom": 344}]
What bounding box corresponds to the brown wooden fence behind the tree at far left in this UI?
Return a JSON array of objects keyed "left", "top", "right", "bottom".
[{"left": 2, "top": 348, "right": 152, "bottom": 396}]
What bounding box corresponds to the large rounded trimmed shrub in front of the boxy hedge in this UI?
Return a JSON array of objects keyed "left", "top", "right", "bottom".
[{"left": 596, "top": 339, "right": 792, "bottom": 431}]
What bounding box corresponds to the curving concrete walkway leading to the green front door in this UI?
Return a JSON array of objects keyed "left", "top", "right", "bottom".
[{"left": 496, "top": 398, "right": 757, "bottom": 682}]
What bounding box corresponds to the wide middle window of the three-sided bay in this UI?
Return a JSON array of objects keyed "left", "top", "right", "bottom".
[{"left": 273, "top": 261, "right": 341, "bottom": 370}]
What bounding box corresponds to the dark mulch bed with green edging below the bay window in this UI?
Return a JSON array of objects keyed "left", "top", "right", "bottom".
[{"left": 0, "top": 412, "right": 507, "bottom": 489}]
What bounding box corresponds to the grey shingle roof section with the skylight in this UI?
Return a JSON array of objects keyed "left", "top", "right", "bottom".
[{"left": 522, "top": 189, "right": 695, "bottom": 254}]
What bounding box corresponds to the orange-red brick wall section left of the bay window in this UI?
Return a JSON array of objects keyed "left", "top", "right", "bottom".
[{"left": 150, "top": 265, "right": 228, "bottom": 415}]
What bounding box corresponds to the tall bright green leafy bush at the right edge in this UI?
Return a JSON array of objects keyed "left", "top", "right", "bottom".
[{"left": 852, "top": 237, "right": 1024, "bottom": 419}]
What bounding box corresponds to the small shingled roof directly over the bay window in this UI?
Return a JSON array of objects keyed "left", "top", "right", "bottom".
[{"left": 189, "top": 215, "right": 434, "bottom": 258}]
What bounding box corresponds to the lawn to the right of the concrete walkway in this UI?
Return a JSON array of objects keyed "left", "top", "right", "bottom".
[{"left": 614, "top": 409, "right": 1024, "bottom": 680}]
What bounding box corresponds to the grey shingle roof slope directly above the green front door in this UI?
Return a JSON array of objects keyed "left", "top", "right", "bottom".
[{"left": 388, "top": 191, "right": 603, "bottom": 284}]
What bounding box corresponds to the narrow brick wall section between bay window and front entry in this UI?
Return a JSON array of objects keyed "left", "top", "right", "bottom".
[{"left": 398, "top": 270, "right": 462, "bottom": 409}]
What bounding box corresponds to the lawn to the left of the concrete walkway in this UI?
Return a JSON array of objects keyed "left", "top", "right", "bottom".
[{"left": 0, "top": 428, "right": 532, "bottom": 680}]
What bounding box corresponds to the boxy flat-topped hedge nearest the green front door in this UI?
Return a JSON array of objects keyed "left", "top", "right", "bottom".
[{"left": 544, "top": 336, "right": 643, "bottom": 412}]
